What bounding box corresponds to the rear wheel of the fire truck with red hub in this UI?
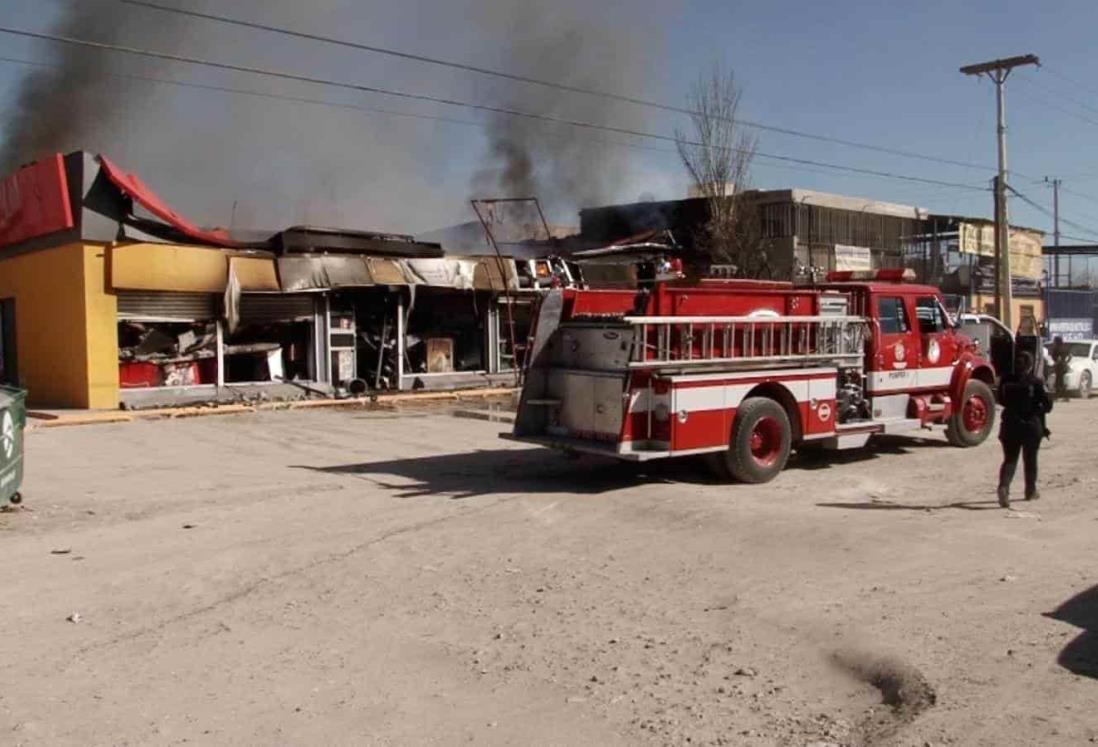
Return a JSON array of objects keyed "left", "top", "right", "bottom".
[{"left": 714, "top": 397, "right": 793, "bottom": 483}]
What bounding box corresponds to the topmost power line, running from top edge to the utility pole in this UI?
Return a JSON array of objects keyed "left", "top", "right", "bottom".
[{"left": 119, "top": 0, "right": 993, "bottom": 171}]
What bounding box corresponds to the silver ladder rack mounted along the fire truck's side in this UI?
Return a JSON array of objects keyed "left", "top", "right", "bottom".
[{"left": 625, "top": 316, "right": 866, "bottom": 369}]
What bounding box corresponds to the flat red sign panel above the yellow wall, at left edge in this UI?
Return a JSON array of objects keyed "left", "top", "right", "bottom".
[{"left": 0, "top": 153, "right": 75, "bottom": 246}]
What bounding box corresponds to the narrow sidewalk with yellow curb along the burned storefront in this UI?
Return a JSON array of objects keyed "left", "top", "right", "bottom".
[{"left": 26, "top": 388, "right": 518, "bottom": 431}]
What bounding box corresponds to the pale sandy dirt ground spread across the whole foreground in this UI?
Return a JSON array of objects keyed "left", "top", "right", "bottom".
[{"left": 0, "top": 401, "right": 1098, "bottom": 746}]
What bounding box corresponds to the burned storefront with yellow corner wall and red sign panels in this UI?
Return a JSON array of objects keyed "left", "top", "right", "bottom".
[{"left": 0, "top": 153, "right": 520, "bottom": 409}]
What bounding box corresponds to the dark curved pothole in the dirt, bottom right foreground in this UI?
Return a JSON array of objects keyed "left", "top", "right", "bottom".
[{"left": 831, "top": 648, "right": 938, "bottom": 745}]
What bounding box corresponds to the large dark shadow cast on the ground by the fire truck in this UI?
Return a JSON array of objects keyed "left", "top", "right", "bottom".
[{"left": 294, "top": 448, "right": 716, "bottom": 499}]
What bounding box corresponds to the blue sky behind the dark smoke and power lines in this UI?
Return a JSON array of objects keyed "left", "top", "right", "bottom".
[{"left": 0, "top": 0, "right": 1098, "bottom": 241}]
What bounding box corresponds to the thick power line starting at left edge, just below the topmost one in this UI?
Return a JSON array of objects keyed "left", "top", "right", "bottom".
[{"left": 0, "top": 26, "right": 983, "bottom": 191}]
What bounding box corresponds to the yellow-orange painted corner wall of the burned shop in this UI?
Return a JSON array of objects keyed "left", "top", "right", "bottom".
[{"left": 0, "top": 244, "right": 119, "bottom": 408}]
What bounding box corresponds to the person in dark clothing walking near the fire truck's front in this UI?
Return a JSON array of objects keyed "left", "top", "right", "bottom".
[{"left": 998, "top": 352, "right": 1052, "bottom": 509}]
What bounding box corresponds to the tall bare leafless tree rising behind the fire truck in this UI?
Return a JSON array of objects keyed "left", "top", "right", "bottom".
[{"left": 675, "top": 64, "right": 765, "bottom": 275}]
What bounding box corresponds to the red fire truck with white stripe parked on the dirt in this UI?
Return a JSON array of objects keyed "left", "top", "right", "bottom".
[{"left": 509, "top": 270, "right": 995, "bottom": 482}]
